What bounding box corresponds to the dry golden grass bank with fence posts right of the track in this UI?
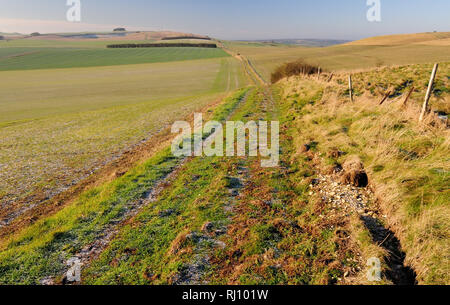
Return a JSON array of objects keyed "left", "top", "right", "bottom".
[{"left": 279, "top": 64, "right": 450, "bottom": 284}]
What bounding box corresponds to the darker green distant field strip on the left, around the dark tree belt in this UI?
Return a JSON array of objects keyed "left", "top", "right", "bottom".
[{"left": 0, "top": 39, "right": 228, "bottom": 71}]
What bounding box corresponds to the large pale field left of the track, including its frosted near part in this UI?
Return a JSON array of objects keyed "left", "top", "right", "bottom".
[{"left": 0, "top": 49, "right": 247, "bottom": 217}]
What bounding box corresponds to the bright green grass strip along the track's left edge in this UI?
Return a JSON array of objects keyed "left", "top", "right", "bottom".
[{"left": 0, "top": 90, "right": 250, "bottom": 284}]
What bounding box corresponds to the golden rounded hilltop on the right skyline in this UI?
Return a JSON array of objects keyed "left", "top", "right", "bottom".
[{"left": 347, "top": 32, "right": 450, "bottom": 46}]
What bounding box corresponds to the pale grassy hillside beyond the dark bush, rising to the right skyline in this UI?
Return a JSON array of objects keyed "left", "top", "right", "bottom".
[{"left": 225, "top": 35, "right": 450, "bottom": 80}]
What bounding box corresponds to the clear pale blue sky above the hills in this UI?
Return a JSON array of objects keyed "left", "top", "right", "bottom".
[{"left": 0, "top": 0, "right": 450, "bottom": 39}]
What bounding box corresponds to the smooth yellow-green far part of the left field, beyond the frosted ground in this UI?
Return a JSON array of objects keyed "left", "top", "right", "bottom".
[{"left": 0, "top": 57, "right": 243, "bottom": 124}]
